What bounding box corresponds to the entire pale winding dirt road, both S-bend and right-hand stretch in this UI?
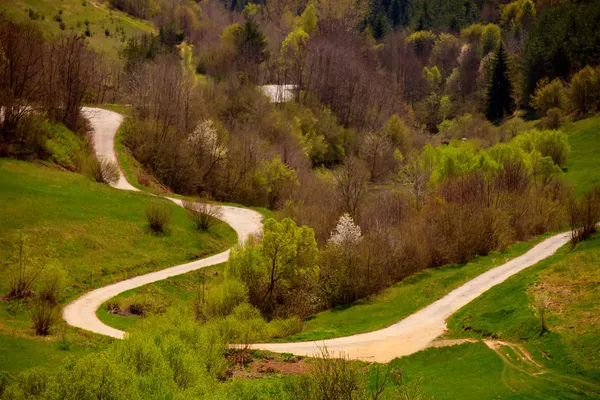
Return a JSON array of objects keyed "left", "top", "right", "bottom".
[{"left": 64, "top": 108, "right": 570, "bottom": 362}]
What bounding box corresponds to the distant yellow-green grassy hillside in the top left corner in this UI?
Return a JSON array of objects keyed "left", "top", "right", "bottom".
[{"left": 0, "top": 0, "right": 154, "bottom": 57}]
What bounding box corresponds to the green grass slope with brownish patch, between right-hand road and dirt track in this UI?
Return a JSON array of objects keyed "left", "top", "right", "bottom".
[{"left": 448, "top": 235, "right": 600, "bottom": 382}]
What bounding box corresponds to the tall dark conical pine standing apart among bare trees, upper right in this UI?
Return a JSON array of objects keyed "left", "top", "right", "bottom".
[{"left": 485, "top": 44, "right": 514, "bottom": 123}]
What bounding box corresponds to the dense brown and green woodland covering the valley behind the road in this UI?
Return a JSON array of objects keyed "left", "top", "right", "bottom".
[{"left": 0, "top": 0, "right": 600, "bottom": 396}]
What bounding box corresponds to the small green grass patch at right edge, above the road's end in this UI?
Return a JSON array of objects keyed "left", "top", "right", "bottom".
[{"left": 564, "top": 116, "right": 600, "bottom": 194}]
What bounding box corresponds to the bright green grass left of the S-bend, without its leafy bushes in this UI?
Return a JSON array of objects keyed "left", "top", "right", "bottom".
[{"left": 0, "top": 159, "right": 237, "bottom": 371}]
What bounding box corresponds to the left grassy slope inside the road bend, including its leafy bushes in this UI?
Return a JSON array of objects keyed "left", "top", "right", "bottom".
[{"left": 0, "top": 159, "right": 237, "bottom": 371}]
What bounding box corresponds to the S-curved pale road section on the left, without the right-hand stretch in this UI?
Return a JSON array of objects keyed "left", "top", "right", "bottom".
[{"left": 63, "top": 107, "right": 262, "bottom": 339}]
